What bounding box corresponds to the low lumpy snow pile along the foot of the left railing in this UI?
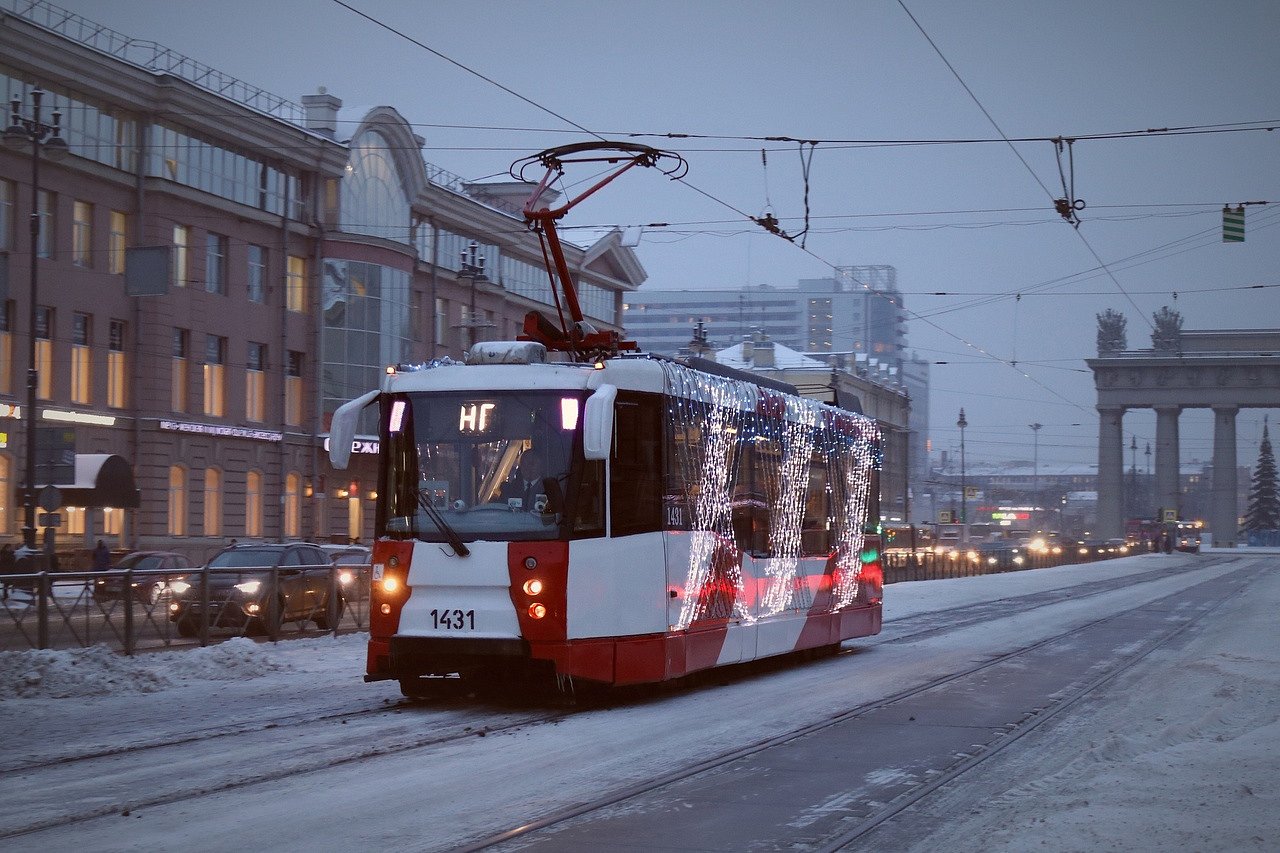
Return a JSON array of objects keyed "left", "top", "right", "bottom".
[{"left": 0, "top": 637, "right": 293, "bottom": 702}]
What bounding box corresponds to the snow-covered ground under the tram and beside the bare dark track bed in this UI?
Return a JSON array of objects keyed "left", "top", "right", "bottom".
[{"left": 0, "top": 551, "right": 1280, "bottom": 853}]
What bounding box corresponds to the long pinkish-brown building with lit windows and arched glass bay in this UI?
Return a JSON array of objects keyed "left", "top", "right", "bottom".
[{"left": 0, "top": 0, "right": 644, "bottom": 558}]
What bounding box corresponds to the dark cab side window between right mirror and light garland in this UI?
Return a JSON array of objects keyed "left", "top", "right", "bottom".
[{"left": 609, "top": 393, "right": 663, "bottom": 535}]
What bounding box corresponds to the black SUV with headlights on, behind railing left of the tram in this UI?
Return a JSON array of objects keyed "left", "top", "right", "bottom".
[{"left": 169, "top": 542, "right": 343, "bottom": 637}]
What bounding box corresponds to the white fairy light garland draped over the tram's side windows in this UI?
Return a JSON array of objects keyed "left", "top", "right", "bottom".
[{"left": 663, "top": 362, "right": 881, "bottom": 630}]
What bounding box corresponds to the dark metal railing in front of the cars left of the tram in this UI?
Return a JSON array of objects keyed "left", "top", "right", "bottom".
[{"left": 0, "top": 566, "right": 370, "bottom": 654}]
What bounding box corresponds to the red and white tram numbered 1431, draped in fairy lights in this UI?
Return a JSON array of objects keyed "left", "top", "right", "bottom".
[{"left": 329, "top": 146, "right": 883, "bottom": 695}]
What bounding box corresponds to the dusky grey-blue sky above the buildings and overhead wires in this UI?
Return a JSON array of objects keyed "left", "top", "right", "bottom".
[{"left": 45, "top": 0, "right": 1280, "bottom": 470}]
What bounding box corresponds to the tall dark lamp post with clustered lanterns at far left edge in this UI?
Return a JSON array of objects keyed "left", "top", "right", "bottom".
[{"left": 4, "top": 88, "right": 67, "bottom": 552}]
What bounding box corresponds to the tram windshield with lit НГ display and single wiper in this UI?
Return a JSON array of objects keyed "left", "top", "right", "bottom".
[{"left": 379, "top": 391, "right": 603, "bottom": 542}]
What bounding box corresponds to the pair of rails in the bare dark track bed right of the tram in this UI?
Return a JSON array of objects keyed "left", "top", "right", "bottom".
[{"left": 452, "top": 561, "right": 1260, "bottom": 853}]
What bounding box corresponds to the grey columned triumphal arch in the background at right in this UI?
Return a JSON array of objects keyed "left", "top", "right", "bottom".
[{"left": 1085, "top": 329, "right": 1280, "bottom": 547}]
